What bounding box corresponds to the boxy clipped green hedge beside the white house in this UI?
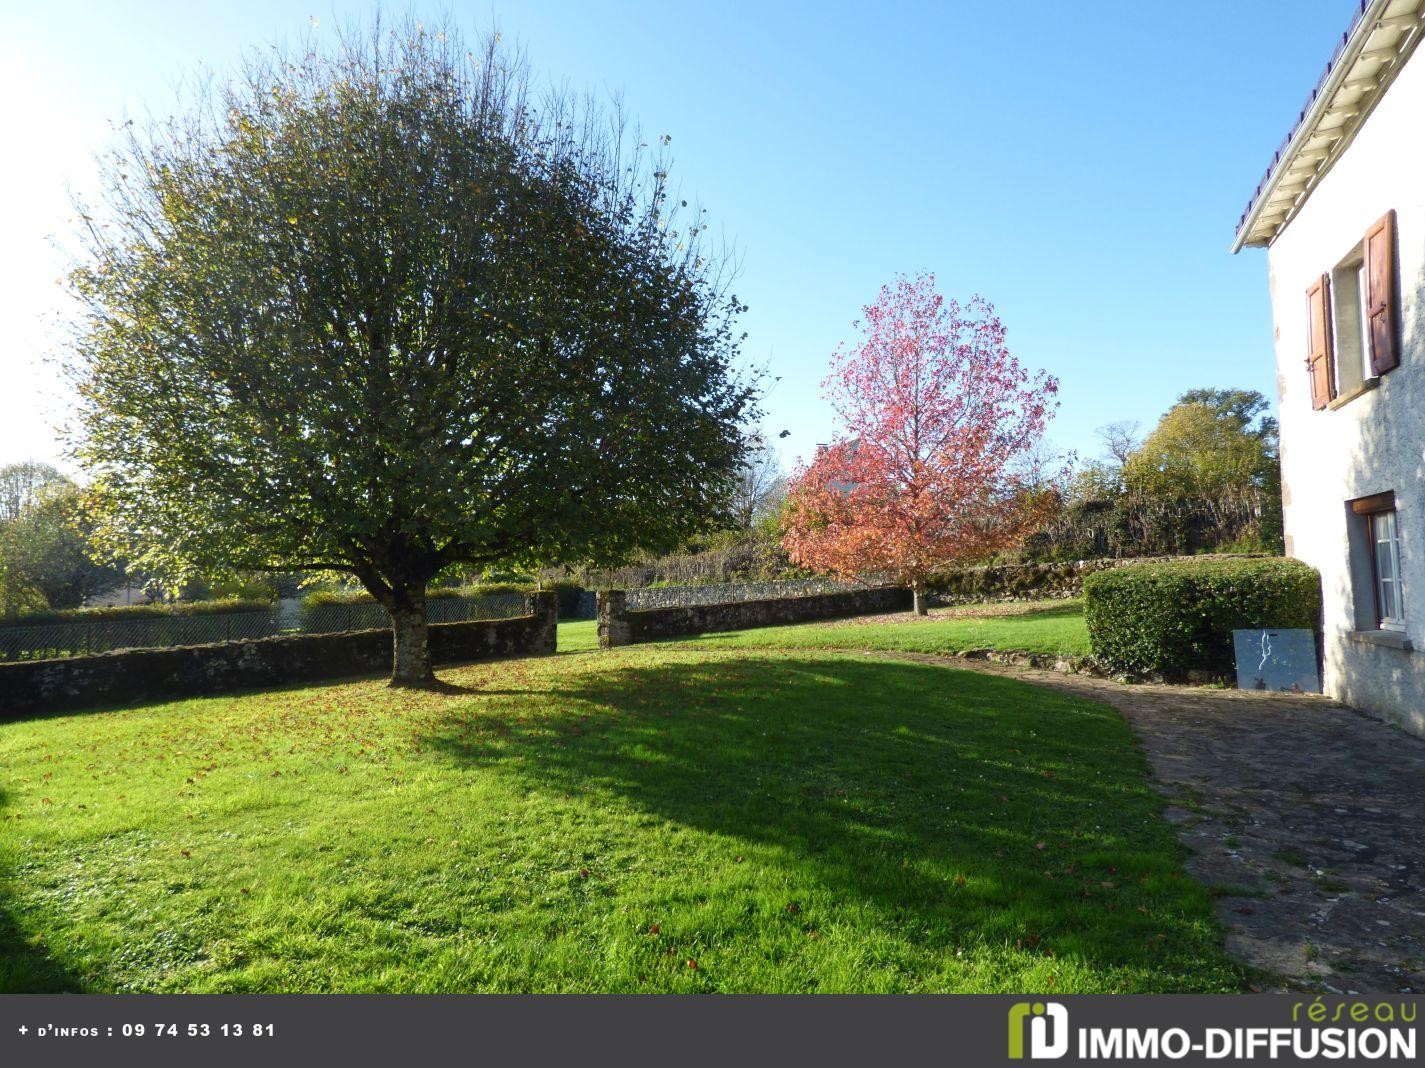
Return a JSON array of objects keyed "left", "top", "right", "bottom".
[{"left": 1083, "top": 559, "right": 1321, "bottom": 679}]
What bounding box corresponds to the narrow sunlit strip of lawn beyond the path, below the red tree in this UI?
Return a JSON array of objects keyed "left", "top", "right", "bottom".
[{"left": 678, "top": 600, "right": 1089, "bottom": 656}]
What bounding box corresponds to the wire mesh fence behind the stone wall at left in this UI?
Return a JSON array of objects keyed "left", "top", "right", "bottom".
[{"left": 0, "top": 593, "right": 530, "bottom": 662}]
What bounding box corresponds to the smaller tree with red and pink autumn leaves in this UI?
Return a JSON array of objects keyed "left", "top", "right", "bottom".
[{"left": 782, "top": 275, "right": 1059, "bottom": 615}]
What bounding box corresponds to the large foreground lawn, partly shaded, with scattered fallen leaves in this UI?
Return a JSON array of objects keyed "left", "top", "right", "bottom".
[{"left": 0, "top": 625, "right": 1241, "bottom": 992}]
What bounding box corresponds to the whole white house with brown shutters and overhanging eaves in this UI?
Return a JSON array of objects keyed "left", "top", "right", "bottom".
[{"left": 1233, "top": 0, "right": 1425, "bottom": 733}]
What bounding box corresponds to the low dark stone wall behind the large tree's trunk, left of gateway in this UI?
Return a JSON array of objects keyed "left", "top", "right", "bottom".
[{"left": 0, "top": 593, "right": 557, "bottom": 720}]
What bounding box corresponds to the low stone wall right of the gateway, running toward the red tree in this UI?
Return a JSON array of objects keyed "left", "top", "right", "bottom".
[{"left": 599, "top": 586, "right": 911, "bottom": 649}]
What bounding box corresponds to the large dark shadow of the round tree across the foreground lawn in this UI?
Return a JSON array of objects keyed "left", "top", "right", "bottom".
[{"left": 423, "top": 656, "right": 1233, "bottom": 990}]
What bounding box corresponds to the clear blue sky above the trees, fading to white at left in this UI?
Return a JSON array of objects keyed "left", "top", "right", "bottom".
[{"left": 0, "top": 0, "right": 1354, "bottom": 463}]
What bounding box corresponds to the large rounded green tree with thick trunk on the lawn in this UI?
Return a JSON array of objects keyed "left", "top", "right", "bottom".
[{"left": 74, "top": 23, "right": 754, "bottom": 684}]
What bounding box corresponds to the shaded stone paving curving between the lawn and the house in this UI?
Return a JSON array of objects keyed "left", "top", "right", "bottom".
[{"left": 866, "top": 653, "right": 1425, "bottom": 994}]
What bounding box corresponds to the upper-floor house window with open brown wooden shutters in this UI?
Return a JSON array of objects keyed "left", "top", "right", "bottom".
[{"left": 1307, "top": 211, "right": 1401, "bottom": 409}]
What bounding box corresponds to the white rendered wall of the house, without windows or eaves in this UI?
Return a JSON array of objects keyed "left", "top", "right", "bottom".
[{"left": 1268, "top": 53, "right": 1425, "bottom": 733}]
